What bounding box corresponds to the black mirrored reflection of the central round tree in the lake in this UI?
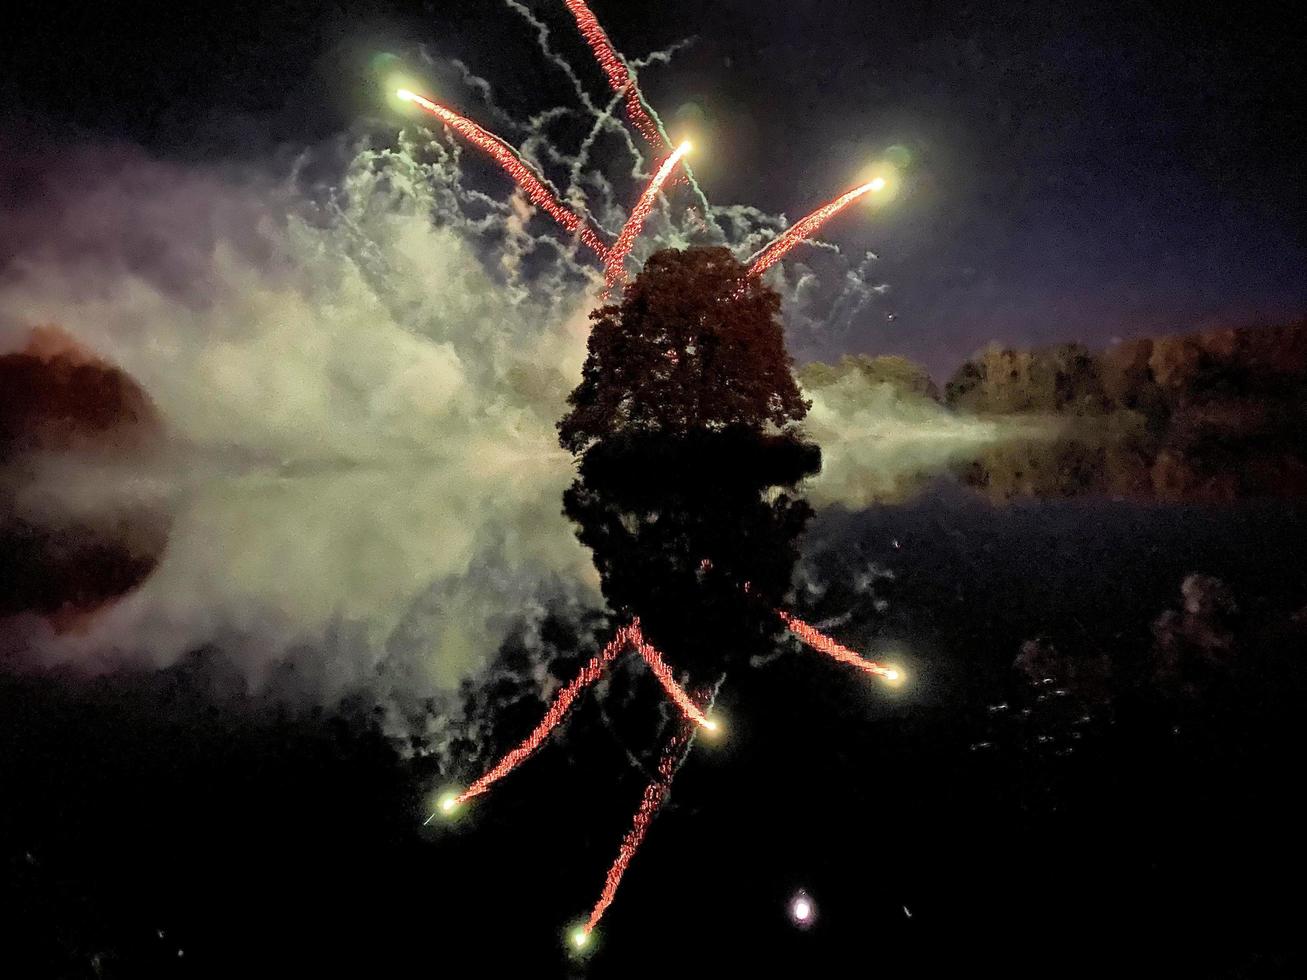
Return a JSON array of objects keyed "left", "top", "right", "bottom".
[{"left": 563, "top": 431, "right": 819, "bottom": 679}]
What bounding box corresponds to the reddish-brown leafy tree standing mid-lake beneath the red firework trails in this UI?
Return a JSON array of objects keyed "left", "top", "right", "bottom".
[{"left": 558, "top": 247, "right": 810, "bottom": 452}]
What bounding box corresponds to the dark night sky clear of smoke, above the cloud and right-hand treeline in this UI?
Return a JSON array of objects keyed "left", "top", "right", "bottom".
[{"left": 0, "top": 0, "right": 1307, "bottom": 375}]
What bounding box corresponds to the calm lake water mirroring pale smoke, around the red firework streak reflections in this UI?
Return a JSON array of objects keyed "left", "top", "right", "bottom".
[{"left": 0, "top": 447, "right": 1307, "bottom": 976}]
